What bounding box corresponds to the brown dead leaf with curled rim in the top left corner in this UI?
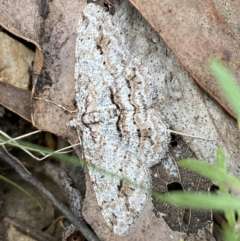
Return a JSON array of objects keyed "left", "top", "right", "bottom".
[{"left": 0, "top": 0, "right": 44, "bottom": 74}]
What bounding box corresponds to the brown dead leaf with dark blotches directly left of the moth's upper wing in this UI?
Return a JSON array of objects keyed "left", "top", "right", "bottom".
[{"left": 32, "top": 0, "right": 85, "bottom": 143}]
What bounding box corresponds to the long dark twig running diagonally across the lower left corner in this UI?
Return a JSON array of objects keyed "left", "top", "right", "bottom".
[{"left": 0, "top": 146, "right": 99, "bottom": 241}]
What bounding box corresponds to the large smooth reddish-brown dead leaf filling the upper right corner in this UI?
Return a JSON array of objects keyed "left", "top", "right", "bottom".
[{"left": 130, "top": 0, "right": 240, "bottom": 115}]
